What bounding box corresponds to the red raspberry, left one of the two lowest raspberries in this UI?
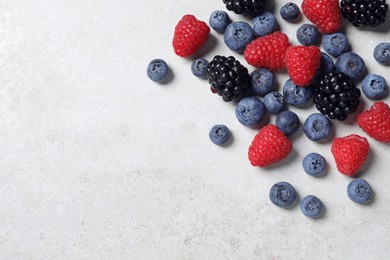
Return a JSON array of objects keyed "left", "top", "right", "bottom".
[{"left": 248, "top": 125, "right": 292, "bottom": 167}]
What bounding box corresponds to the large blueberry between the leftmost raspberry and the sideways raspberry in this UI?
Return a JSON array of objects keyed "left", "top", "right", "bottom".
[{"left": 223, "top": 22, "right": 255, "bottom": 53}]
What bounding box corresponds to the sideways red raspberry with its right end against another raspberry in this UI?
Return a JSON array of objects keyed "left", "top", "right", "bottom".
[{"left": 244, "top": 32, "right": 290, "bottom": 71}]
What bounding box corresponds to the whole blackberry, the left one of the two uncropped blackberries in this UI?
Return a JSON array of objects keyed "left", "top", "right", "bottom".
[{"left": 207, "top": 55, "right": 250, "bottom": 102}]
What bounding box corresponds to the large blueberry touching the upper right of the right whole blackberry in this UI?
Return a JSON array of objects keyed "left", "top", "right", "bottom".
[{"left": 335, "top": 52, "right": 366, "bottom": 79}]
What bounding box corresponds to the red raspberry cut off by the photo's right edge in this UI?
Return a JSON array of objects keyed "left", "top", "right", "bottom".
[{"left": 357, "top": 101, "right": 390, "bottom": 143}]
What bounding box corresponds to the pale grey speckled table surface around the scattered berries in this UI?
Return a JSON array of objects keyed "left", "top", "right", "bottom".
[{"left": 0, "top": 0, "right": 390, "bottom": 259}]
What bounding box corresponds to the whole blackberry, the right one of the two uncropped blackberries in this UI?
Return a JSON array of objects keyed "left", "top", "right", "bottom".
[{"left": 313, "top": 72, "right": 360, "bottom": 121}]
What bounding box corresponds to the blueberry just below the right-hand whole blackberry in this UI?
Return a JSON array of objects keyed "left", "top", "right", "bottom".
[{"left": 303, "top": 113, "right": 332, "bottom": 141}]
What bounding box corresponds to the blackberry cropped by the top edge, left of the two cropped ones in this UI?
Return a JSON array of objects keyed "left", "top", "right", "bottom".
[{"left": 223, "top": 0, "right": 268, "bottom": 17}]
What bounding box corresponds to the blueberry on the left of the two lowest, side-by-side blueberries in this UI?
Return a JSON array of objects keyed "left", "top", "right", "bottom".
[{"left": 269, "top": 182, "right": 297, "bottom": 208}]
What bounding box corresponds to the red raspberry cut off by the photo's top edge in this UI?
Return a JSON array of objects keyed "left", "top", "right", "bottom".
[{"left": 302, "top": 0, "right": 341, "bottom": 33}]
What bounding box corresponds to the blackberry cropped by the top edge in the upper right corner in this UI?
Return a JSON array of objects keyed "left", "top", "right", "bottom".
[{"left": 340, "top": 0, "right": 389, "bottom": 27}]
